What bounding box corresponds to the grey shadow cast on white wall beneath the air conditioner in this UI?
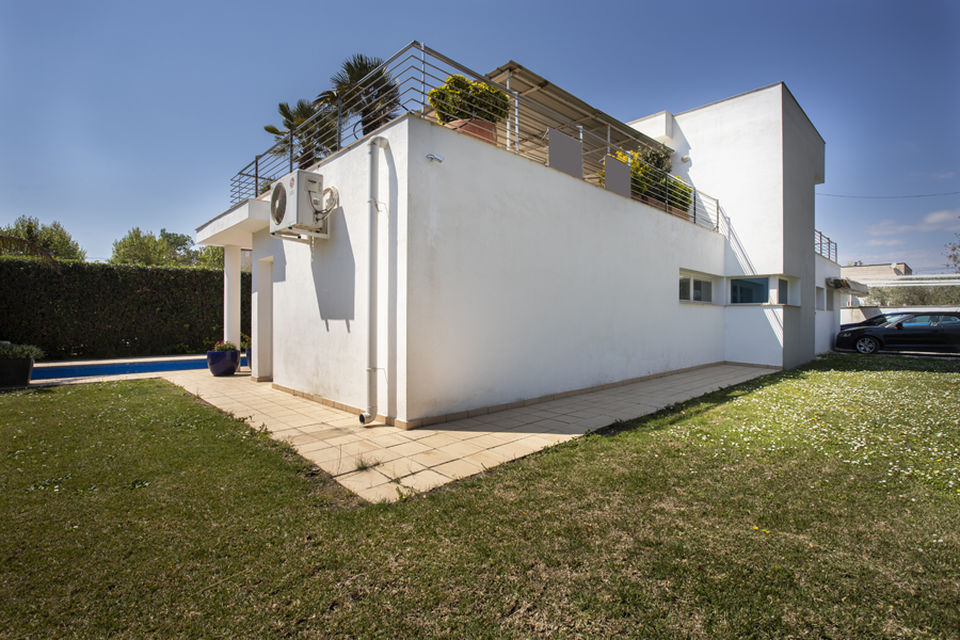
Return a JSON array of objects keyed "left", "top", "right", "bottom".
[{"left": 310, "top": 207, "right": 357, "bottom": 333}]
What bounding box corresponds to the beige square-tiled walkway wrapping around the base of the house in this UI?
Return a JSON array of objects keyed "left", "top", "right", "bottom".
[{"left": 154, "top": 364, "right": 777, "bottom": 502}]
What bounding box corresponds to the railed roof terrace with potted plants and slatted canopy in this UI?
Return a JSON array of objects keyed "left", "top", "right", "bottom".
[{"left": 230, "top": 42, "right": 720, "bottom": 229}]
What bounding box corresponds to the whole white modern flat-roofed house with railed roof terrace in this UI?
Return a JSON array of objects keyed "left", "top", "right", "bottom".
[{"left": 197, "top": 43, "right": 840, "bottom": 427}]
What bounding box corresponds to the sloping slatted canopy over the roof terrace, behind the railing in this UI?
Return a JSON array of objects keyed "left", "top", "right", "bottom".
[{"left": 487, "top": 60, "right": 672, "bottom": 151}]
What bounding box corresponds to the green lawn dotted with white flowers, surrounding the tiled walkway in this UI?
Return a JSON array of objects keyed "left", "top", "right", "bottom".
[{"left": 0, "top": 355, "right": 960, "bottom": 638}]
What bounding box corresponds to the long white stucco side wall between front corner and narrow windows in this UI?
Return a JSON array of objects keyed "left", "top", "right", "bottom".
[{"left": 407, "top": 121, "right": 724, "bottom": 419}]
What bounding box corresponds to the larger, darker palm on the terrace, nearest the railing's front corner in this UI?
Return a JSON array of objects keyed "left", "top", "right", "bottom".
[{"left": 314, "top": 53, "right": 400, "bottom": 135}]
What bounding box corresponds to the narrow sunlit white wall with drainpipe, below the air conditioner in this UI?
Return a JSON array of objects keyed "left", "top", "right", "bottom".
[{"left": 253, "top": 119, "right": 408, "bottom": 416}]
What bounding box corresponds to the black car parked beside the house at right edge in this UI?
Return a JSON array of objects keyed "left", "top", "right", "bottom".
[{"left": 836, "top": 311, "right": 960, "bottom": 353}]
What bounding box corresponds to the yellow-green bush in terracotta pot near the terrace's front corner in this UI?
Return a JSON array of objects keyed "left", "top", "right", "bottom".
[{"left": 427, "top": 74, "right": 510, "bottom": 144}]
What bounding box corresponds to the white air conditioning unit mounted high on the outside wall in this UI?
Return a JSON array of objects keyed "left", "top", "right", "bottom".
[{"left": 270, "top": 170, "right": 330, "bottom": 238}]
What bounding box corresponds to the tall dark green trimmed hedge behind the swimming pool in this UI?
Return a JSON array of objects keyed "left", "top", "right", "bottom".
[{"left": 0, "top": 256, "right": 251, "bottom": 360}]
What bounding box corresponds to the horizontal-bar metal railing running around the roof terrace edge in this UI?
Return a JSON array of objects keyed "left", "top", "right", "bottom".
[{"left": 230, "top": 42, "right": 720, "bottom": 230}]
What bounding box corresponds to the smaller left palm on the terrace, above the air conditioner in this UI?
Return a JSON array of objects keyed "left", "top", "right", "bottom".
[{"left": 263, "top": 100, "right": 339, "bottom": 169}]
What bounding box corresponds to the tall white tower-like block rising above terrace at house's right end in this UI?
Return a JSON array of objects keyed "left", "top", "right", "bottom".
[{"left": 632, "top": 83, "right": 824, "bottom": 368}]
